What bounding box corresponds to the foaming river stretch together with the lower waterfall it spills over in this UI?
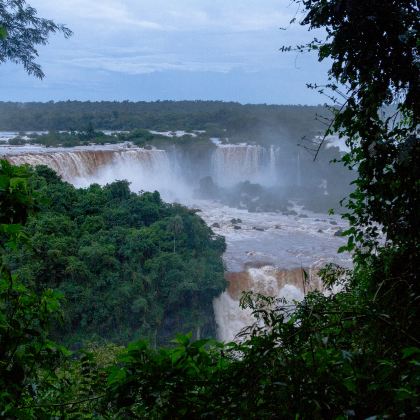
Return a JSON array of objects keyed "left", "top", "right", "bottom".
[{"left": 199, "top": 201, "right": 351, "bottom": 342}]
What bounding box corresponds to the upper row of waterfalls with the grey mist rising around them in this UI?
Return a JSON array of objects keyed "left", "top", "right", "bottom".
[{"left": 2, "top": 130, "right": 353, "bottom": 214}]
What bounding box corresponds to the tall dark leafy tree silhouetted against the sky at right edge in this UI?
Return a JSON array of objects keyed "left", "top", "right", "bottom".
[{"left": 290, "top": 0, "right": 420, "bottom": 249}]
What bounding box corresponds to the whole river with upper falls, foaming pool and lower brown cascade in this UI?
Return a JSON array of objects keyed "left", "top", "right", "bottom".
[{"left": 0, "top": 141, "right": 351, "bottom": 341}]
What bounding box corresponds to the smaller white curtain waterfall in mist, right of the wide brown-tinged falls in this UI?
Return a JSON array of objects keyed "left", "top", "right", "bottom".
[{"left": 211, "top": 144, "right": 278, "bottom": 186}]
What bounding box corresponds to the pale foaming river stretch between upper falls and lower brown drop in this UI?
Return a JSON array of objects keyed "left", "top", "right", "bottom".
[{"left": 191, "top": 200, "right": 351, "bottom": 272}]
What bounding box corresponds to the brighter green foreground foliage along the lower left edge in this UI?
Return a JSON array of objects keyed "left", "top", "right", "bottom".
[{"left": 0, "top": 160, "right": 63, "bottom": 418}]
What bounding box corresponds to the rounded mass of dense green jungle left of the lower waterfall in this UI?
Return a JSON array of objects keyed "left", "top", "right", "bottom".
[{"left": 4, "top": 162, "right": 225, "bottom": 344}]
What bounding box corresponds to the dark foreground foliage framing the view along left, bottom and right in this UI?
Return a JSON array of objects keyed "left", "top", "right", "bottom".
[{"left": 0, "top": 0, "right": 420, "bottom": 419}]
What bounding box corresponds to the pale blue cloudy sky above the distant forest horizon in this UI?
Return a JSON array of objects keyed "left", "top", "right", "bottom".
[{"left": 0, "top": 0, "right": 328, "bottom": 104}]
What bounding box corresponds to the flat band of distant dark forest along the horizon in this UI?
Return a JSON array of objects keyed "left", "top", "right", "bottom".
[{"left": 0, "top": 101, "right": 329, "bottom": 142}]
